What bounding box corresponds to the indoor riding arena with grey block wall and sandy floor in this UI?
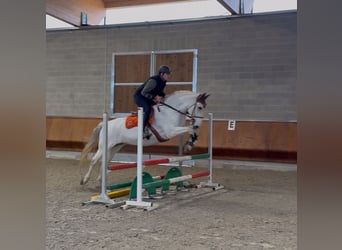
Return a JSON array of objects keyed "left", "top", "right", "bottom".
[{"left": 46, "top": 1, "right": 297, "bottom": 250}]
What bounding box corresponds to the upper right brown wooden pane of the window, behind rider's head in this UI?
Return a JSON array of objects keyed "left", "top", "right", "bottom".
[{"left": 156, "top": 53, "right": 194, "bottom": 82}]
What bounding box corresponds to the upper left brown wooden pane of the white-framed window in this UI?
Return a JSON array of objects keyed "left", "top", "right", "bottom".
[{"left": 115, "top": 55, "right": 151, "bottom": 83}]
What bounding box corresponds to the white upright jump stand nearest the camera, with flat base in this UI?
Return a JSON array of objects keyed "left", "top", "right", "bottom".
[{"left": 124, "top": 107, "right": 152, "bottom": 209}]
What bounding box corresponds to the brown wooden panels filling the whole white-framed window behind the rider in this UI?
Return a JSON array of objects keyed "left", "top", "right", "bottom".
[{"left": 113, "top": 53, "right": 193, "bottom": 114}]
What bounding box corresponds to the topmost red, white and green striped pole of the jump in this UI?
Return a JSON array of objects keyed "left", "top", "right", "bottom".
[{"left": 108, "top": 153, "right": 210, "bottom": 171}]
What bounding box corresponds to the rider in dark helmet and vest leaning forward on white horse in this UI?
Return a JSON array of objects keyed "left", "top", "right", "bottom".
[{"left": 134, "top": 65, "right": 171, "bottom": 139}]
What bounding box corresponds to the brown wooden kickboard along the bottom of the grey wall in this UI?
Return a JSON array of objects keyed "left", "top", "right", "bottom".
[{"left": 46, "top": 117, "right": 297, "bottom": 162}]
